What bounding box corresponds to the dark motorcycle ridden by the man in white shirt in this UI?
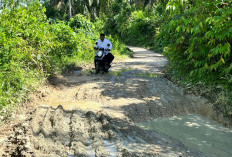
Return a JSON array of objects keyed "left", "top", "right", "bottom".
[{"left": 94, "top": 43, "right": 110, "bottom": 74}]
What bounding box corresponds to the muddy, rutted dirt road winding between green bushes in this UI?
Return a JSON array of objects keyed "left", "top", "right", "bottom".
[{"left": 0, "top": 47, "right": 232, "bottom": 157}]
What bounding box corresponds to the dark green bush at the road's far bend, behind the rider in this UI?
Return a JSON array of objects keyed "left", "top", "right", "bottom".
[{"left": 104, "top": 2, "right": 157, "bottom": 47}]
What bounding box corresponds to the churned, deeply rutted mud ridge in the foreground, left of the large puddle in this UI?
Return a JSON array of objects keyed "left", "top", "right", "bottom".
[{"left": 2, "top": 106, "right": 192, "bottom": 157}]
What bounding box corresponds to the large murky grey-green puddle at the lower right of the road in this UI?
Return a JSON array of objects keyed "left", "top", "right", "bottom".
[{"left": 137, "top": 115, "right": 232, "bottom": 157}]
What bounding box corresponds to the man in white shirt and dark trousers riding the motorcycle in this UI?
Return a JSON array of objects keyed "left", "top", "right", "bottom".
[{"left": 94, "top": 33, "right": 114, "bottom": 68}]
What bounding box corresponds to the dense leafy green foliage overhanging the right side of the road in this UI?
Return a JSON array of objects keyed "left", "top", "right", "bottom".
[{"left": 155, "top": 0, "right": 232, "bottom": 117}]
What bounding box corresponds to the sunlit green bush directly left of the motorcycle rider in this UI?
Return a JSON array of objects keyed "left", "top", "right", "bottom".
[{"left": 50, "top": 21, "right": 94, "bottom": 69}]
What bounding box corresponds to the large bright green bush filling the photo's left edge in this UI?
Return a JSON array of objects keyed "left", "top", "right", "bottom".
[{"left": 0, "top": 4, "right": 51, "bottom": 108}]
